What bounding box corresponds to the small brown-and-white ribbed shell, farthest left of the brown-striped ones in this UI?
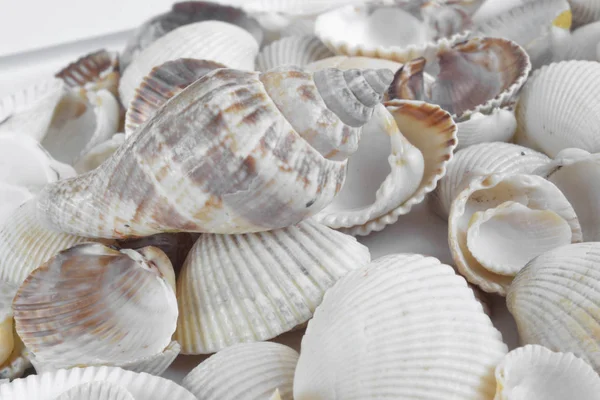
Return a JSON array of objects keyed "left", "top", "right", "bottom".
[{"left": 55, "top": 50, "right": 121, "bottom": 96}]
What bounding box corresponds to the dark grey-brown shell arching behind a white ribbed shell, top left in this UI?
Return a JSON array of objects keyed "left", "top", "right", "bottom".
[{"left": 120, "top": 1, "right": 263, "bottom": 71}]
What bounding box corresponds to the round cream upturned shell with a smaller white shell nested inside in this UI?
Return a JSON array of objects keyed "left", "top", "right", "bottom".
[{"left": 448, "top": 174, "right": 582, "bottom": 296}]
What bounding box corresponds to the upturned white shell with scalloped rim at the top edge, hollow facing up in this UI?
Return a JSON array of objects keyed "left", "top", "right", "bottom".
[{"left": 315, "top": 2, "right": 470, "bottom": 63}]
